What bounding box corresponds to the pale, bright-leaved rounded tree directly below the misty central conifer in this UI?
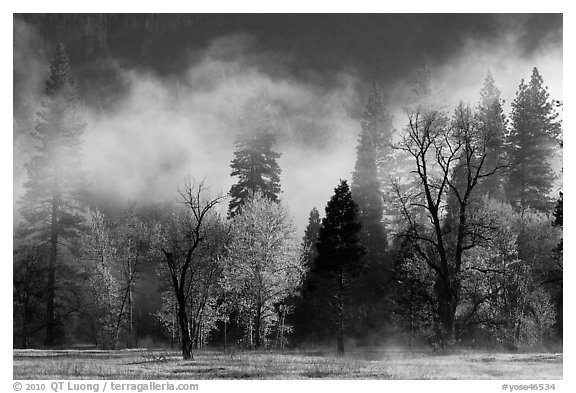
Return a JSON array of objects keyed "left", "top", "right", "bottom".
[{"left": 223, "top": 193, "right": 304, "bottom": 348}]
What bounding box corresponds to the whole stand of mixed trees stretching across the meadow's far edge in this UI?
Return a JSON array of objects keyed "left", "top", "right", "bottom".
[{"left": 13, "top": 14, "right": 563, "bottom": 359}]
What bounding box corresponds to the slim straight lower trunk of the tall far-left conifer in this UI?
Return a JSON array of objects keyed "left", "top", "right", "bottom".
[{"left": 44, "top": 195, "right": 59, "bottom": 346}]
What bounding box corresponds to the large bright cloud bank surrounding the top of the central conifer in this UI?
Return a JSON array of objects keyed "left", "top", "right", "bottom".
[{"left": 78, "top": 37, "right": 361, "bottom": 229}]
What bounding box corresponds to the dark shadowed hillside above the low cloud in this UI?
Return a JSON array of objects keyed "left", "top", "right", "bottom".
[{"left": 14, "top": 14, "right": 562, "bottom": 108}]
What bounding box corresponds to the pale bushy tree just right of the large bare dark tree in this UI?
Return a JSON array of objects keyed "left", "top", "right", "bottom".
[{"left": 461, "top": 198, "right": 561, "bottom": 349}]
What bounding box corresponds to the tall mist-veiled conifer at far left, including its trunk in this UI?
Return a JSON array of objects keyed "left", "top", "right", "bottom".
[{"left": 19, "top": 43, "right": 85, "bottom": 345}]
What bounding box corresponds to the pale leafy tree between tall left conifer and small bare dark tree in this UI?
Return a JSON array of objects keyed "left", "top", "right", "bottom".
[{"left": 78, "top": 206, "right": 157, "bottom": 348}]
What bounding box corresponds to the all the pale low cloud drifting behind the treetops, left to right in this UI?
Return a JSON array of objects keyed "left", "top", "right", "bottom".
[{"left": 14, "top": 19, "right": 562, "bottom": 231}]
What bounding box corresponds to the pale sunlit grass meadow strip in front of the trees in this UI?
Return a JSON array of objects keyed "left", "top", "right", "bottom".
[{"left": 13, "top": 349, "right": 562, "bottom": 380}]
